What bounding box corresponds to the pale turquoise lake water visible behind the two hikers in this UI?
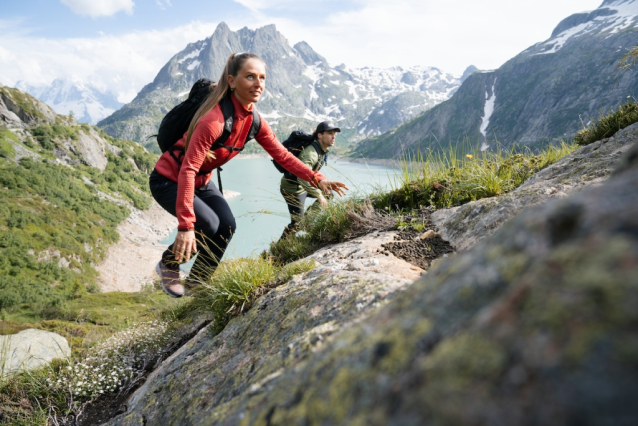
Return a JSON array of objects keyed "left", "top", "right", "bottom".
[{"left": 161, "top": 158, "right": 398, "bottom": 270}]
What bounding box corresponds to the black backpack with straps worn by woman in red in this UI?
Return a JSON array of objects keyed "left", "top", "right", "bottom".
[{"left": 156, "top": 78, "right": 261, "bottom": 191}]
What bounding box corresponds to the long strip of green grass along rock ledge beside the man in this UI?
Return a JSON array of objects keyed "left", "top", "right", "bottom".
[{"left": 269, "top": 143, "right": 577, "bottom": 264}]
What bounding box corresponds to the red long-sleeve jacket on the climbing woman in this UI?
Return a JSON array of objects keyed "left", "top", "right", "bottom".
[{"left": 155, "top": 95, "right": 325, "bottom": 231}]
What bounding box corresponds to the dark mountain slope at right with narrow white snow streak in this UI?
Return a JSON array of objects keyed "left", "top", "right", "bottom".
[{"left": 355, "top": 0, "right": 638, "bottom": 158}]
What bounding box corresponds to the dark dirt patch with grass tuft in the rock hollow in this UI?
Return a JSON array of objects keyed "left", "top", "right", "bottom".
[{"left": 381, "top": 209, "right": 455, "bottom": 270}]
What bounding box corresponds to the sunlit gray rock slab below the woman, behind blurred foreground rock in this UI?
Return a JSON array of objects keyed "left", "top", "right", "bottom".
[{"left": 104, "top": 232, "right": 422, "bottom": 425}]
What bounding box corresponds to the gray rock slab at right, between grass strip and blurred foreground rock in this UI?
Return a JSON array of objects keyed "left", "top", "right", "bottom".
[{"left": 432, "top": 123, "right": 638, "bottom": 250}]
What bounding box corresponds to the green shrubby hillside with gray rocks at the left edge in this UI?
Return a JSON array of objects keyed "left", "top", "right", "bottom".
[{"left": 0, "top": 86, "right": 155, "bottom": 317}]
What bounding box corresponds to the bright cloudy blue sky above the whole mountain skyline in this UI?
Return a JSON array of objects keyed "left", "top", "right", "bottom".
[{"left": 0, "top": 0, "right": 602, "bottom": 102}]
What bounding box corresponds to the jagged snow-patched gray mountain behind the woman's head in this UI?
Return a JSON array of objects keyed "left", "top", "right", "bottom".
[{"left": 99, "top": 22, "right": 460, "bottom": 151}]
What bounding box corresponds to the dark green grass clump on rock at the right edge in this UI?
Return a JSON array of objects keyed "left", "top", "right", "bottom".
[{"left": 574, "top": 100, "right": 638, "bottom": 145}]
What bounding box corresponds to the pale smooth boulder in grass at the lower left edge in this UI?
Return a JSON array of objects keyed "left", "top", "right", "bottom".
[{"left": 0, "top": 328, "right": 71, "bottom": 377}]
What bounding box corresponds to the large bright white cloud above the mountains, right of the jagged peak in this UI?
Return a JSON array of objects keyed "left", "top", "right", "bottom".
[{"left": 230, "top": 0, "right": 600, "bottom": 74}]
